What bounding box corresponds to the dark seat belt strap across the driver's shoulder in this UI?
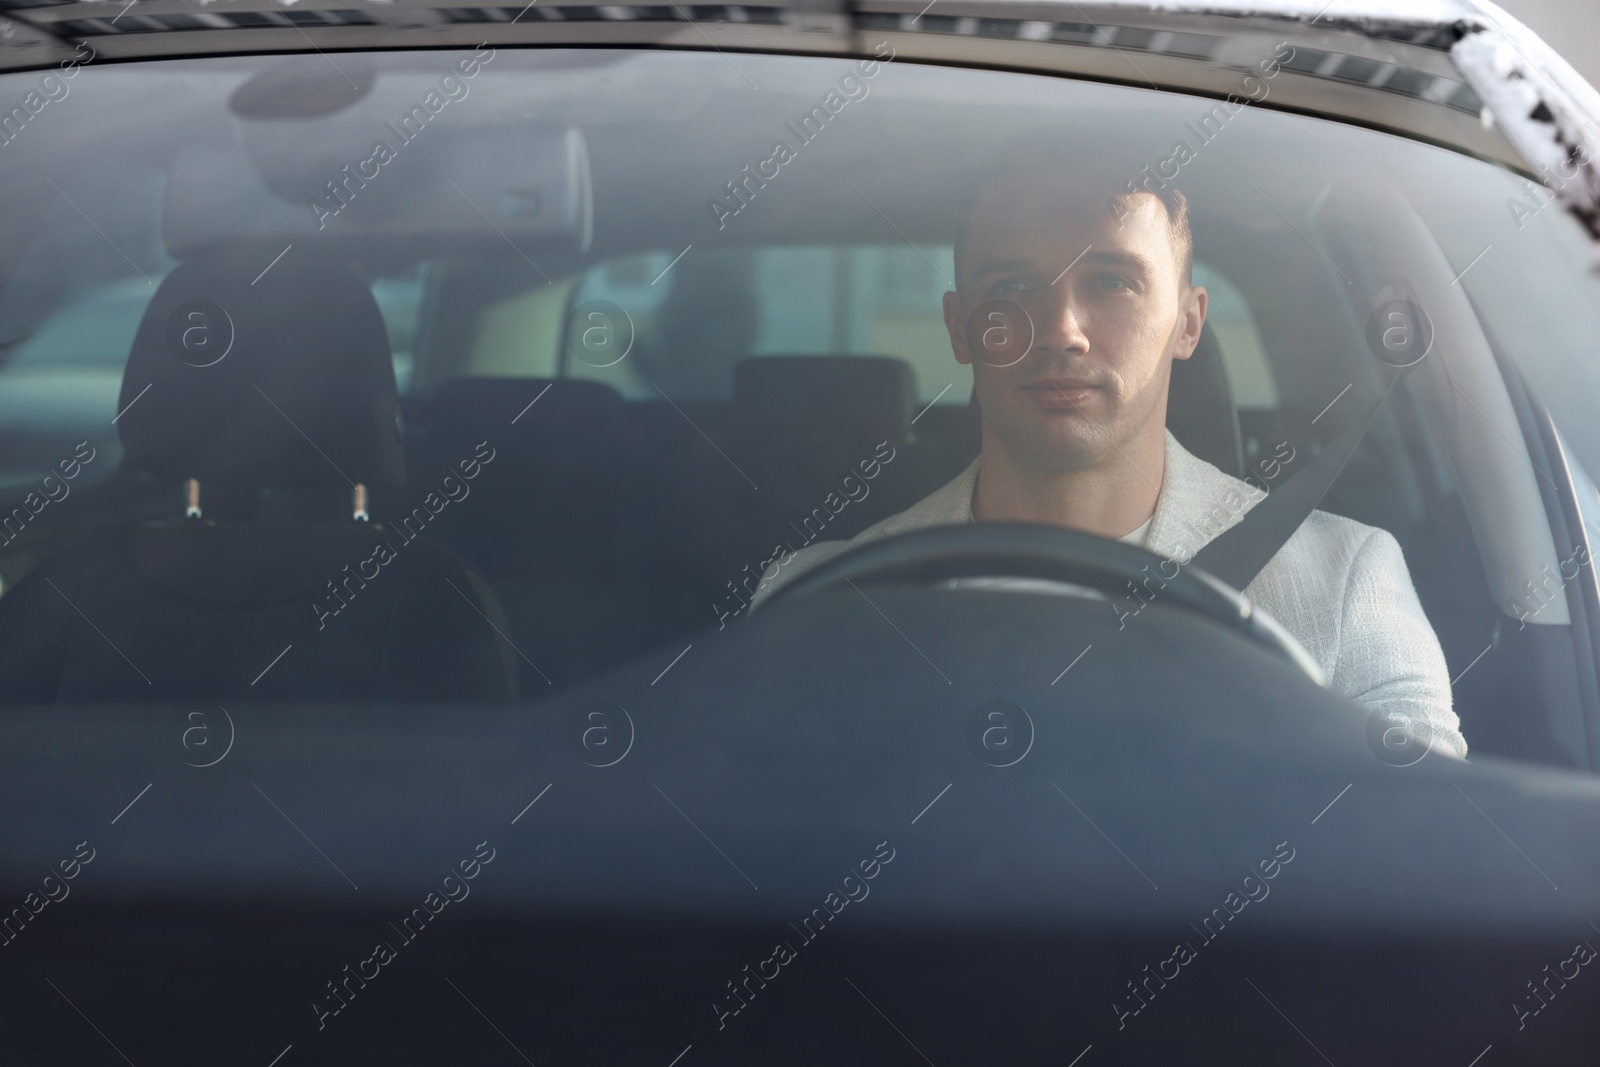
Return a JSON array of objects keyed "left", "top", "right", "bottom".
[{"left": 1190, "top": 370, "right": 1405, "bottom": 590}]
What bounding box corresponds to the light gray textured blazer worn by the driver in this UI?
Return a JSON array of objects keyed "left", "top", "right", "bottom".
[{"left": 752, "top": 432, "right": 1467, "bottom": 757}]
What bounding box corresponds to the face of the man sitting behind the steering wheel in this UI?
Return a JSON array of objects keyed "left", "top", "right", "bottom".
[{"left": 944, "top": 176, "right": 1206, "bottom": 472}]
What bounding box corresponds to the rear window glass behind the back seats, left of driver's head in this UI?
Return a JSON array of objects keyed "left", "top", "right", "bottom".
[{"left": 562, "top": 245, "right": 971, "bottom": 403}]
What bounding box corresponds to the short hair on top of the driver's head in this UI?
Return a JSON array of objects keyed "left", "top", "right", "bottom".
[{"left": 955, "top": 141, "right": 1194, "bottom": 285}]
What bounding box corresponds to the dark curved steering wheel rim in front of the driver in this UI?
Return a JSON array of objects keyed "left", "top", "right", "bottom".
[{"left": 766, "top": 523, "right": 1328, "bottom": 688}]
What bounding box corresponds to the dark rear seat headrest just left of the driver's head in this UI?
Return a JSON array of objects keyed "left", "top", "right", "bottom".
[{"left": 733, "top": 355, "right": 917, "bottom": 440}]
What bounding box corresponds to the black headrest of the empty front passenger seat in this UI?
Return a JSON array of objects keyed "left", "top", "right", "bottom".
[{"left": 117, "top": 253, "right": 405, "bottom": 490}]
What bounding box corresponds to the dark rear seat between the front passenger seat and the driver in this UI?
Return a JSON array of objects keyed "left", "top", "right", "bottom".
[{"left": 408, "top": 355, "right": 971, "bottom": 681}]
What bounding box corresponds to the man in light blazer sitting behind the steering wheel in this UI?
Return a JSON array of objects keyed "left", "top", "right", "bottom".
[{"left": 757, "top": 154, "right": 1467, "bottom": 755}]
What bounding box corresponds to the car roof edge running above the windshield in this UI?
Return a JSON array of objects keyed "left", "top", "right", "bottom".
[{"left": 0, "top": 0, "right": 1600, "bottom": 248}]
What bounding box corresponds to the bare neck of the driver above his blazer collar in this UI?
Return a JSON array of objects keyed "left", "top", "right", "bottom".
[{"left": 973, "top": 427, "right": 1166, "bottom": 539}]
